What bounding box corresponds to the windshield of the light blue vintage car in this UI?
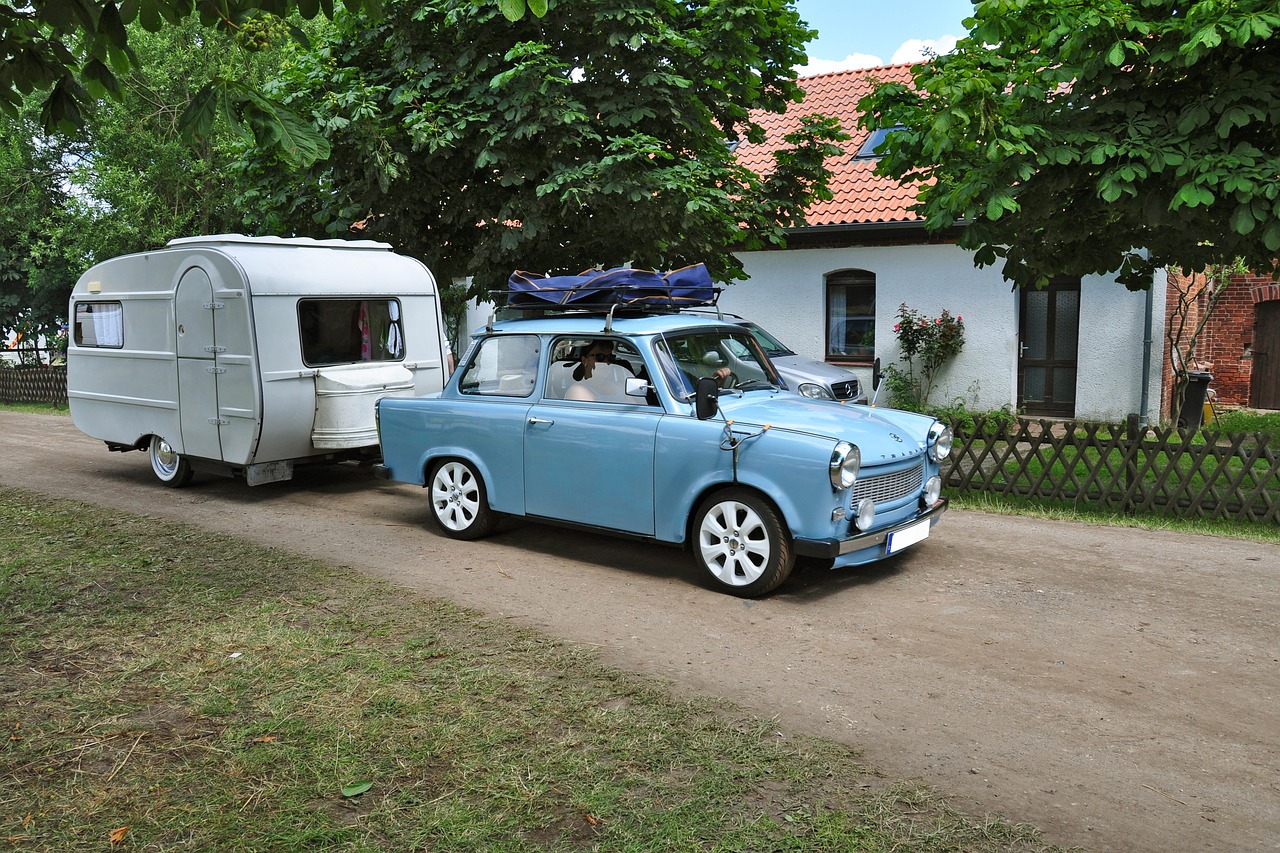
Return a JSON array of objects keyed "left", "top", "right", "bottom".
[{"left": 654, "top": 328, "right": 782, "bottom": 400}]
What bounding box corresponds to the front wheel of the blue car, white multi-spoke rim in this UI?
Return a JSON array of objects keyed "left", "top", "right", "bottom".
[{"left": 691, "top": 488, "right": 795, "bottom": 598}]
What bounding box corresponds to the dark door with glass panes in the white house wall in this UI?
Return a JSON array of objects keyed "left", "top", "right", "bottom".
[{"left": 1018, "top": 279, "right": 1080, "bottom": 418}]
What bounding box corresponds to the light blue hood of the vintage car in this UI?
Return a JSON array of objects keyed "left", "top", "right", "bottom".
[{"left": 719, "top": 391, "right": 934, "bottom": 464}]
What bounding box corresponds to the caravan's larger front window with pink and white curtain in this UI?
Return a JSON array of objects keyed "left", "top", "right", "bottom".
[{"left": 298, "top": 298, "right": 404, "bottom": 366}]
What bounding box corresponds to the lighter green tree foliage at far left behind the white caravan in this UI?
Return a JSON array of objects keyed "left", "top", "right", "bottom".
[{"left": 0, "top": 20, "right": 280, "bottom": 332}]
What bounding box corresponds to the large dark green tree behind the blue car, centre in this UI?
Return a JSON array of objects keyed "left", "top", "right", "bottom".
[{"left": 243, "top": 0, "right": 845, "bottom": 293}]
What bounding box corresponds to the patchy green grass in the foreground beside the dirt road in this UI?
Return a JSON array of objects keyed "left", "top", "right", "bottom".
[{"left": 0, "top": 489, "right": 1064, "bottom": 853}]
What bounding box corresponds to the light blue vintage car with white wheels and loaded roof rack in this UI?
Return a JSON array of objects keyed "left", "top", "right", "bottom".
[{"left": 375, "top": 268, "right": 951, "bottom": 597}]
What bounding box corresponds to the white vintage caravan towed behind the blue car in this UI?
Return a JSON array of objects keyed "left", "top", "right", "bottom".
[{"left": 67, "top": 234, "right": 449, "bottom": 487}]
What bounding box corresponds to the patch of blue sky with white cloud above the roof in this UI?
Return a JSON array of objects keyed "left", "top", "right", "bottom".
[{"left": 795, "top": 0, "right": 973, "bottom": 77}]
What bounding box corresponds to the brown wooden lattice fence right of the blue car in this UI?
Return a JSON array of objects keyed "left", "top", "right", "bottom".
[{"left": 943, "top": 418, "right": 1280, "bottom": 524}]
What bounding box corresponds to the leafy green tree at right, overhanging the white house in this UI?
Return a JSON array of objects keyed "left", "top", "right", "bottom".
[{"left": 860, "top": 0, "right": 1280, "bottom": 289}]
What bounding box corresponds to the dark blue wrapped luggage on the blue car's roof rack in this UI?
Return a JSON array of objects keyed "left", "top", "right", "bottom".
[{"left": 497, "top": 264, "right": 723, "bottom": 315}]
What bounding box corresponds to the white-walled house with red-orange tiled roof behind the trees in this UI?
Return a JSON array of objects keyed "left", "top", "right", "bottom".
[{"left": 719, "top": 65, "right": 1166, "bottom": 421}]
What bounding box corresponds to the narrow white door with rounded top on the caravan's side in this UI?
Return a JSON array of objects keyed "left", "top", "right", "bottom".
[{"left": 175, "top": 266, "right": 257, "bottom": 465}]
